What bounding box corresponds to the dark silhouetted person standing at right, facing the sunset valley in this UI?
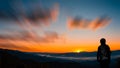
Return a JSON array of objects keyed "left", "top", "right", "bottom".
[{"left": 97, "top": 38, "right": 111, "bottom": 68}]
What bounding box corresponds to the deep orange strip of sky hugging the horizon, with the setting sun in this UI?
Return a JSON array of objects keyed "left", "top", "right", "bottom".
[{"left": 0, "top": 42, "right": 120, "bottom": 53}]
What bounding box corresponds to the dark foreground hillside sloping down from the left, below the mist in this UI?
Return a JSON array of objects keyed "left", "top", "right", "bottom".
[{"left": 0, "top": 49, "right": 120, "bottom": 68}]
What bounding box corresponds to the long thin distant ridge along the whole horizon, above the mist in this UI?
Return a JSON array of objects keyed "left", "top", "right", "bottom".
[{"left": 0, "top": 49, "right": 120, "bottom": 57}]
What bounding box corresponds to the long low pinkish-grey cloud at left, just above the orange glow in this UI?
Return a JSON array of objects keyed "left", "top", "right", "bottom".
[{"left": 0, "top": 31, "right": 60, "bottom": 43}]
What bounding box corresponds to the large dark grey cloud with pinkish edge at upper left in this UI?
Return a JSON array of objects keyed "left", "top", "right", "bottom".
[{"left": 0, "top": 0, "right": 59, "bottom": 26}]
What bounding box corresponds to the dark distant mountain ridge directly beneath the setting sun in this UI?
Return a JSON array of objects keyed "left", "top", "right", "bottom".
[{"left": 37, "top": 50, "right": 120, "bottom": 57}]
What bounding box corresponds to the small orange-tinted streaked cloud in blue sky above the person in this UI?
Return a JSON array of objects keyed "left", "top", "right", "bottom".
[{"left": 67, "top": 16, "right": 111, "bottom": 30}]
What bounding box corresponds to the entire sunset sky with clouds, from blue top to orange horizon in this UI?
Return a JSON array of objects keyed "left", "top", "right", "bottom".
[{"left": 0, "top": 0, "right": 120, "bottom": 53}]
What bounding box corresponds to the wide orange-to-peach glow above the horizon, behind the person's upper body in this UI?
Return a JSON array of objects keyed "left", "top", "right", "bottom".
[{"left": 0, "top": 37, "right": 120, "bottom": 53}]
